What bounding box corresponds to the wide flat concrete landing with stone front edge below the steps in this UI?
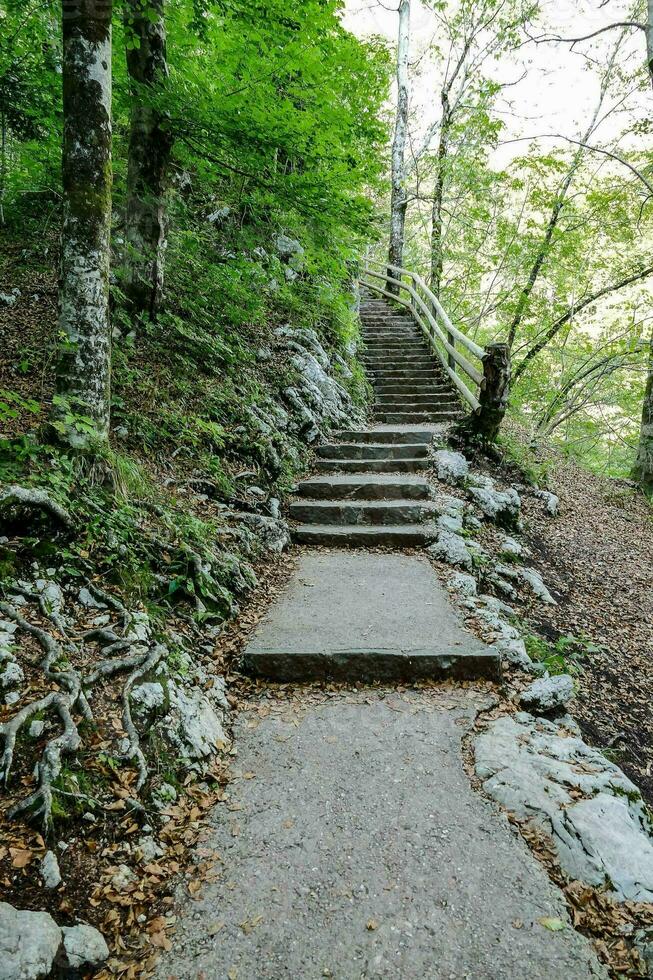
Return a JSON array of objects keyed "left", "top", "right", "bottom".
[{"left": 244, "top": 550, "right": 501, "bottom": 681}]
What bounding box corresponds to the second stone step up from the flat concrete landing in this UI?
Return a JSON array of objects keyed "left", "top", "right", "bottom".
[{"left": 289, "top": 499, "right": 435, "bottom": 527}]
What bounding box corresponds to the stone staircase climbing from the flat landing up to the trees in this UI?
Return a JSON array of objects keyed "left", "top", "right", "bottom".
[{"left": 290, "top": 299, "right": 460, "bottom": 547}]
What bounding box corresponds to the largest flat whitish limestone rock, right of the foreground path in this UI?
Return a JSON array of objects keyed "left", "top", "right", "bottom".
[{"left": 475, "top": 714, "right": 653, "bottom": 902}]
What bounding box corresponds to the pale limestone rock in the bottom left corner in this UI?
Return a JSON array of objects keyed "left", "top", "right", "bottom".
[{"left": 0, "top": 902, "right": 61, "bottom": 980}]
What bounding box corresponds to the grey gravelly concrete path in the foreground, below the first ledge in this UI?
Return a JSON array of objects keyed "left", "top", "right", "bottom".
[{"left": 158, "top": 689, "right": 607, "bottom": 980}]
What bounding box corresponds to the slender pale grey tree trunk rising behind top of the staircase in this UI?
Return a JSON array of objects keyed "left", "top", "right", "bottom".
[{"left": 387, "top": 0, "right": 410, "bottom": 295}]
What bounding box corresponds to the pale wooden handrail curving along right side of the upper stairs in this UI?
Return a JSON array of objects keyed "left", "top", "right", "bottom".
[{"left": 361, "top": 262, "right": 486, "bottom": 411}]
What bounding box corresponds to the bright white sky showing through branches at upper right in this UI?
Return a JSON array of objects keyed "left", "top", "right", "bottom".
[{"left": 344, "top": 0, "right": 653, "bottom": 166}]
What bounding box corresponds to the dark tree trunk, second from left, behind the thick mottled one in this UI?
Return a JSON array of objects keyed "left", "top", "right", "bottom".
[{"left": 124, "top": 0, "right": 172, "bottom": 318}]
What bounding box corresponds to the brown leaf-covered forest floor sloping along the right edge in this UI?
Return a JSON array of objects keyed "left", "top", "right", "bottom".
[{"left": 510, "top": 451, "right": 653, "bottom": 805}]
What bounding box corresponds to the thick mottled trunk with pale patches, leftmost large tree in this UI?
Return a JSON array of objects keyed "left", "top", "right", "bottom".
[{"left": 54, "top": 0, "right": 112, "bottom": 448}]
